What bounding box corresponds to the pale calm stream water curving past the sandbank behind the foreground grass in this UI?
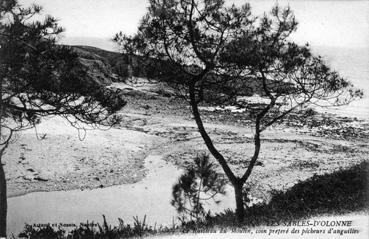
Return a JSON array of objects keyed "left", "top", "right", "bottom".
[{"left": 7, "top": 155, "right": 234, "bottom": 235}]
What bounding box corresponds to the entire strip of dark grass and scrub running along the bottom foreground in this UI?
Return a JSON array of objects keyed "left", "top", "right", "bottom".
[{"left": 19, "top": 162, "right": 369, "bottom": 239}]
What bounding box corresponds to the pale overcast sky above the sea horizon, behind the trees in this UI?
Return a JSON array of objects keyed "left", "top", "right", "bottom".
[{"left": 20, "top": 0, "right": 369, "bottom": 50}]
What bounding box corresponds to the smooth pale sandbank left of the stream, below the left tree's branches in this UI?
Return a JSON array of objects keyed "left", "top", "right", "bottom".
[{"left": 5, "top": 115, "right": 162, "bottom": 197}]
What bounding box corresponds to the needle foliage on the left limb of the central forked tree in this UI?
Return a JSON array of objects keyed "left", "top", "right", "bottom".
[{"left": 115, "top": 0, "right": 250, "bottom": 87}]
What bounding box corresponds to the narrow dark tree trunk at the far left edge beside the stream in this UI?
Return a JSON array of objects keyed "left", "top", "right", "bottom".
[{"left": 0, "top": 160, "right": 8, "bottom": 237}]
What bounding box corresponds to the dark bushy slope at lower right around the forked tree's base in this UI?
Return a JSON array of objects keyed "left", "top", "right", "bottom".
[{"left": 200, "top": 162, "right": 369, "bottom": 227}]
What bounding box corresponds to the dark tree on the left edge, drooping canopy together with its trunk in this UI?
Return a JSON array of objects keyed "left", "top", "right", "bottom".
[{"left": 0, "top": 0, "right": 126, "bottom": 237}]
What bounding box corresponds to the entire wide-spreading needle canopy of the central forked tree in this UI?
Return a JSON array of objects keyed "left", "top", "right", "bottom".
[{"left": 115, "top": 0, "right": 361, "bottom": 109}]
